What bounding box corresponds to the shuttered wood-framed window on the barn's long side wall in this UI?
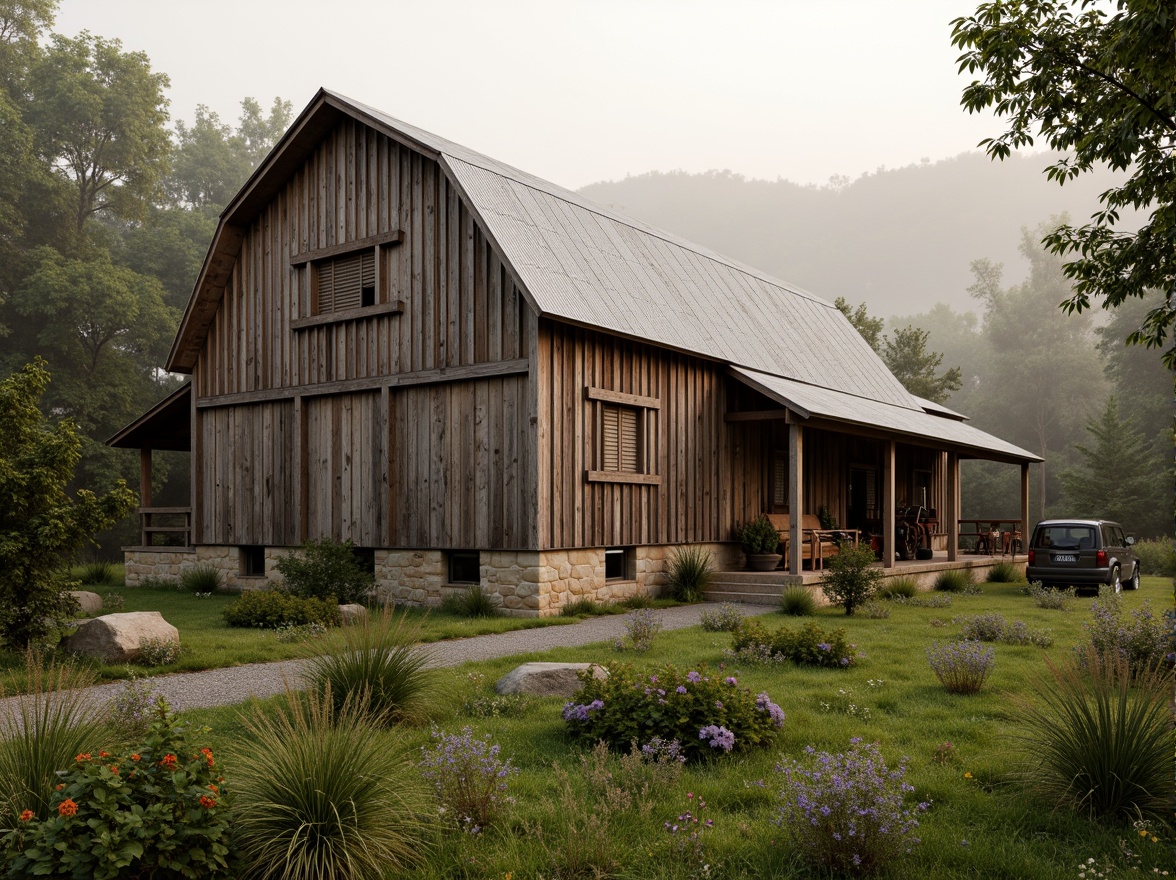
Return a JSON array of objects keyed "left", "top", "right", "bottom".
[{"left": 586, "top": 388, "right": 661, "bottom": 484}]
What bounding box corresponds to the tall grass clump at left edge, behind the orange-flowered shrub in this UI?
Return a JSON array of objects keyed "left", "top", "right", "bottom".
[{"left": 0, "top": 652, "right": 106, "bottom": 828}]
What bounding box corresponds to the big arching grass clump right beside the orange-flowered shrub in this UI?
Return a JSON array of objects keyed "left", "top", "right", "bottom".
[{"left": 234, "top": 694, "right": 429, "bottom": 880}]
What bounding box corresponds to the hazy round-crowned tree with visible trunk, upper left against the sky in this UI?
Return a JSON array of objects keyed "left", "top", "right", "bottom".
[{"left": 28, "top": 31, "right": 171, "bottom": 245}]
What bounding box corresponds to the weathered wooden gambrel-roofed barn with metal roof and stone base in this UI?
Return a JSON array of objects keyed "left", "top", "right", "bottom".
[{"left": 111, "top": 91, "right": 1037, "bottom": 615}]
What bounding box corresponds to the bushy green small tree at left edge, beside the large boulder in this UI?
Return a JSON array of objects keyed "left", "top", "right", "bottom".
[{"left": 0, "top": 359, "right": 136, "bottom": 648}]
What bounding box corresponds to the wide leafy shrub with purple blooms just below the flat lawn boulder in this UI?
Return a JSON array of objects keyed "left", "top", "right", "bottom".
[{"left": 563, "top": 664, "right": 784, "bottom": 759}]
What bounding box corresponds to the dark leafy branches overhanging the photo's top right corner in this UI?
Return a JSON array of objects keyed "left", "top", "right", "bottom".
[{"left": 951, "top": 0, "right": 1176, "bottom": 366}]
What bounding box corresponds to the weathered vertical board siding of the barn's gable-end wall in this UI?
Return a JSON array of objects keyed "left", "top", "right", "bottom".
[{"left": 193, "top": 121, "right": 536, "bottom": 548}]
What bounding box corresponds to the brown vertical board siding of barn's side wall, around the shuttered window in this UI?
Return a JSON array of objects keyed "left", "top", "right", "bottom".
[{"left": 537, "top": 321, "right": 767, "bottom": 549}]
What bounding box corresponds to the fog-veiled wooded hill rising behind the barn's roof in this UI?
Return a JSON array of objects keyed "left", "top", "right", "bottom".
[{"left": 580, "top": 152, "right": 1128, "bottom": 316}]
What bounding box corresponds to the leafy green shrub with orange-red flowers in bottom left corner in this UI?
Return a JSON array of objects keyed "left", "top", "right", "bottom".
[{"left": 5, "top": 700, "right": 229, "bottom": 880}]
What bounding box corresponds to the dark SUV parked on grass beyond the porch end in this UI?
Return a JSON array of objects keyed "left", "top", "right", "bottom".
[{"left": 1025, "top": 520, "right": 1140, "bottom": 593}]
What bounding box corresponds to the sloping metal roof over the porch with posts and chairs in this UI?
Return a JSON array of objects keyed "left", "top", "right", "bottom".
[{"left": 729, "top": 367, "right": 1042, "bottom": 464}]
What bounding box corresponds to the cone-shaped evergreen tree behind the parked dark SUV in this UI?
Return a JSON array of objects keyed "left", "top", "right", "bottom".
[{"left": 1061, "top": 394, "right": 1174, "bottom": 535}]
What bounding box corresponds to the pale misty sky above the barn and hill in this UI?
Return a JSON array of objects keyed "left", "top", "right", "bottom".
[{"left": 54, "top": 0, "right": 997, "bottom": 188}]
